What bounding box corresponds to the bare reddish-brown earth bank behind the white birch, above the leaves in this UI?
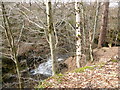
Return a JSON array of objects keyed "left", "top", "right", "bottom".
[{"left": 64, "top": 47, "right": 120, "bottom": 72}]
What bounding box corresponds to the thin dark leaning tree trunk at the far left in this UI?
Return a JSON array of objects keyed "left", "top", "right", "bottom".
[{"left": 2, "top": 2, "right": 22, "bottom": 89}]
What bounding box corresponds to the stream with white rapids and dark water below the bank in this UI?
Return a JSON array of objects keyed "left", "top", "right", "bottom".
[{"left": 2, "top": 55, "right": 69, "bottom": 88}]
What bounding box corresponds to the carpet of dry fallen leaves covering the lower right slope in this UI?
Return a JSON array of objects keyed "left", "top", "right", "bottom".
[{"left": 40, "top": 62, "right": 119, "bottom": 88}]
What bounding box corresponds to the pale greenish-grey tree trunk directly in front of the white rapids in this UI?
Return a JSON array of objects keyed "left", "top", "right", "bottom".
[{"left": 46, "top": 0, "right": 57, "bottom": 75}]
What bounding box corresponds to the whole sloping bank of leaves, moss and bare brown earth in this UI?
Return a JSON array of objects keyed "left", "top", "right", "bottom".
[{"left": 37, "top": 47, "right": 120, "bottom": 88}]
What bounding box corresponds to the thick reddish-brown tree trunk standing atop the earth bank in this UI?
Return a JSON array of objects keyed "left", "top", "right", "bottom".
[{"left": 98, "top": 0, "right": 109, "bottom": 48}]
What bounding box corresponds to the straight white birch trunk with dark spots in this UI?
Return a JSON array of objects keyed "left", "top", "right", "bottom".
[{"left": 75, "top": 0, "right": 81, "bottom": 68}]
